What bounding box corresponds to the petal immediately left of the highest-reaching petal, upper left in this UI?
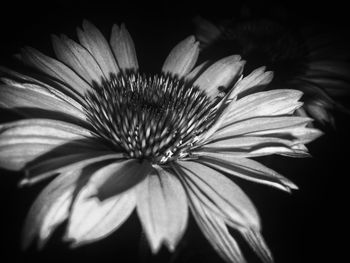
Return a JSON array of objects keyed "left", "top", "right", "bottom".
[{"left": 52, "top": 35, "right": 104, "bottom": 85}]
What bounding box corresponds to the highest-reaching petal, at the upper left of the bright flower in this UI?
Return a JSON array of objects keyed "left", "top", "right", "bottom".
[{"left": 78, "top": 20, "right": 119, "bottom": 77}]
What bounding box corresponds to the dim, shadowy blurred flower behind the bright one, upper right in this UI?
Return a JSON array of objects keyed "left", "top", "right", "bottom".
[{"left": 194, "top": 6, "right": 350, "bottom": 126}]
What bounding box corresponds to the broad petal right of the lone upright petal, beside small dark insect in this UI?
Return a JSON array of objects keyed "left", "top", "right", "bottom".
[{"left": 194, "top": 55, "right": 245, "bottom": 97}]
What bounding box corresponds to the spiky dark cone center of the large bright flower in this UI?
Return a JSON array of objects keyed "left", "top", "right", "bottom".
[{"left": 85, "top": 72, "right": 214, "bottom": 163}]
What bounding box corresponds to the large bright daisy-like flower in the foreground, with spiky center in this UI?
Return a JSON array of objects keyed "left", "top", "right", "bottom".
[{"left": 0, "top": 21, "right": 320, "bottom": 262}]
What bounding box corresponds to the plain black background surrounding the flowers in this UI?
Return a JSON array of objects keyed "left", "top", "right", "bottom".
[{"left": 0, "top": 0, "right": 350, "bottom": 263}]
